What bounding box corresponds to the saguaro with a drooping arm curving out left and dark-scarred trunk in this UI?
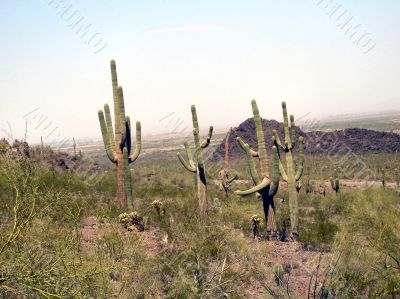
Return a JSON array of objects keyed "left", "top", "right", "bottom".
[{"left": 235, "top": 100, "right": 279, "bottom": 238}]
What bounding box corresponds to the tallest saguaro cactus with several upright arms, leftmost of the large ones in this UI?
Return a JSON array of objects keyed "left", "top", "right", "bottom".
[{"left": 98, "top": 60, "right": 141, "bottom": 209}]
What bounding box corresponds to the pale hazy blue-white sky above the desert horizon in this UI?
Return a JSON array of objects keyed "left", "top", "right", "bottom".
[{"left": 0, "top": 0, "right": 400, "bottom": 142}]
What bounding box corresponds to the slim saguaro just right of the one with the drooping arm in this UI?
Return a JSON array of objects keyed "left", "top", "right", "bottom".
[{"left": 273, "top": 102, "right": 304, "bottom": 238}]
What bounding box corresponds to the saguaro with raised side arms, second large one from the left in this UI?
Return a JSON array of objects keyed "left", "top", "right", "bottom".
[{"left": 178, "top": 105, "right": 213, "bottom": 218}]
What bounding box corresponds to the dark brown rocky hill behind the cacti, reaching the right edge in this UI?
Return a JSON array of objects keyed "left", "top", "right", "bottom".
[{"left": 213, "top": 118, "right": 400, "bottom": 161}]
